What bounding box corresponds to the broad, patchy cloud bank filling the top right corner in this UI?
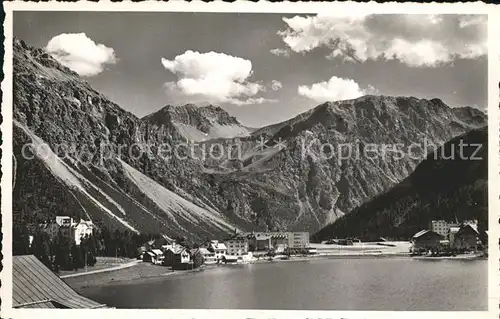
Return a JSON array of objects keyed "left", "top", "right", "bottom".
[{"left": 278, "top": 14, "right": 487, "bottom": 67}]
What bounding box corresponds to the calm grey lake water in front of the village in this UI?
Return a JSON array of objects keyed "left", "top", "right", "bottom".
[{"left": 80, "top": 258, "right": 488, "bottom": 310}]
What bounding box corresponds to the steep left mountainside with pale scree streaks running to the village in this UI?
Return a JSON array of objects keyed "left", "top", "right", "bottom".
[{"left": 13, "top": 40, "right": 240, "bottom": 237}]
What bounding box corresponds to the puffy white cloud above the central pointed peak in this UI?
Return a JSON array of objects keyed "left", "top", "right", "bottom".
[{"left": 161, "top": 50, "right": 265, "bottom": 105}]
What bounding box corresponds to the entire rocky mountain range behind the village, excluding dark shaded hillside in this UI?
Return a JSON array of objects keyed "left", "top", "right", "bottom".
[{"left": 13, "top": 40, "right": 486, "bottom": 238}]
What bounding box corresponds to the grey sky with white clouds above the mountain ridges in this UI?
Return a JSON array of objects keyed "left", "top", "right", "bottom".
[{"left": 14, "top": 12, "right": 487, "bottom": 127}]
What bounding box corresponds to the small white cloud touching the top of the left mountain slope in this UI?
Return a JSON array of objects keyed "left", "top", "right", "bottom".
[{"left": 45, "top": 33, "right": 117, "bottom": 76}]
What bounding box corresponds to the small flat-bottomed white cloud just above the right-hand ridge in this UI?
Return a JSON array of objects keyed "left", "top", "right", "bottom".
[{"left": 298, "top": 76, "right": 377, "bottom": 103}]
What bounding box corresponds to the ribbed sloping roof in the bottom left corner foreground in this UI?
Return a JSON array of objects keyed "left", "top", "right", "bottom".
[{"left": 12, "top": 255, "right": 106, "bottom": 308}]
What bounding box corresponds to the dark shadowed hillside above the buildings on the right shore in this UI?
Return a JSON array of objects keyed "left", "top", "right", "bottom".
[{"left": 313, "top": 127, "right": 488, "bottom": 241}]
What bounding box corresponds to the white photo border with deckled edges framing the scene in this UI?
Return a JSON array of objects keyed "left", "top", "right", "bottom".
[{"left": 0, "top": 1, "right": 500, "bottom": 319}]
